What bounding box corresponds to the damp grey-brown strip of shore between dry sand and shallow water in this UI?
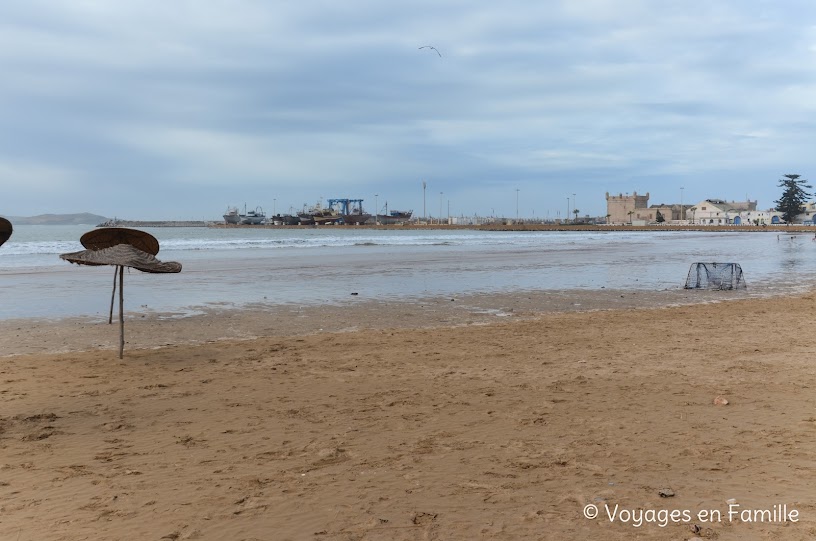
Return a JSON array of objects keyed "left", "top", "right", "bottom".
[{"left": 0, "top": 288, "right": 756, "bottom": 359}]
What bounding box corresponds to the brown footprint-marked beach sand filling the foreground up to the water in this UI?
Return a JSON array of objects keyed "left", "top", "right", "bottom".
[{"left": 0, "top": 294, "right": 816, "bottom": 541}]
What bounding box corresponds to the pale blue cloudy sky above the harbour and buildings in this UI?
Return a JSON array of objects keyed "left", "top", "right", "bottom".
[{"left": 0, "top": 0, "right": 816, "bottom": 220}]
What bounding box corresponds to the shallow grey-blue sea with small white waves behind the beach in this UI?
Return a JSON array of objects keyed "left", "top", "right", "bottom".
[{"left": 0, "top": 225, "right": 816, "bottom": 320}]
